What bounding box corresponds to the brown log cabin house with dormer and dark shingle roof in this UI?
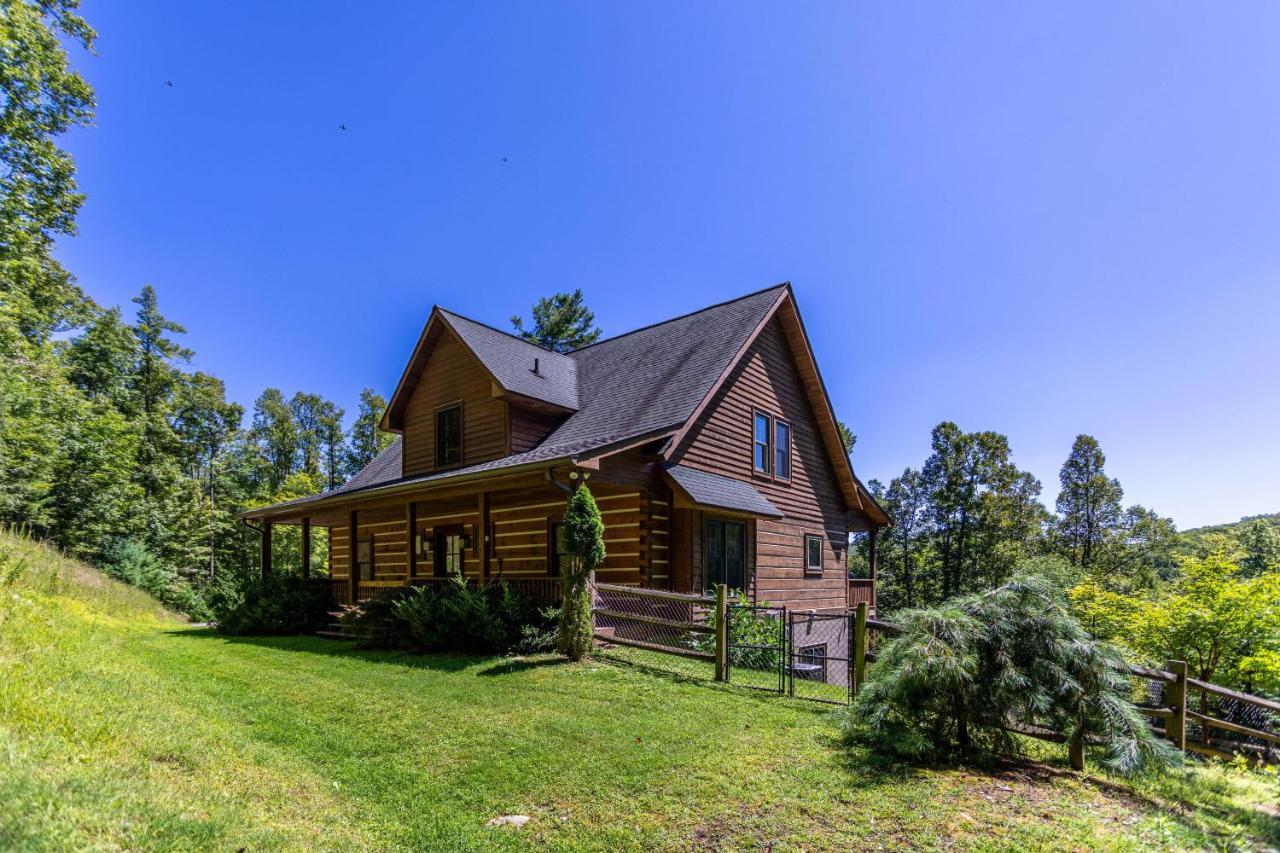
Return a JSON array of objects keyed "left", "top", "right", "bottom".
[{"left": 242, "top": 284, "right": 888, "bottom": 611}]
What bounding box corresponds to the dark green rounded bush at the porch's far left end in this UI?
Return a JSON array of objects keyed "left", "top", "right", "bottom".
[{"left": 210, "top": 573, "right": 333, "bottom": 635}]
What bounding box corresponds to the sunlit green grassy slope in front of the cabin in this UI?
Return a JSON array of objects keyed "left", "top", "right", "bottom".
[{"left": 0, "top": 534, "right": 1280, "bottom": 849}]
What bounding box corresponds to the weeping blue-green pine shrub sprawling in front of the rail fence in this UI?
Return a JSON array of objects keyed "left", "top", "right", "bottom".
[{"left": 845, "top": 575, "right": 1176, "bottom": 774}]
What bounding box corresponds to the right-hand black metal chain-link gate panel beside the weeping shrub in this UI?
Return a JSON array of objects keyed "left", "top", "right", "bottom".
[{"left": 786, "top": 612, "right": 854, "bottom": 704}]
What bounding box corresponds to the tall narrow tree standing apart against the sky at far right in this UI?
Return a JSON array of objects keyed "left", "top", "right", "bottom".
[{"left": 1057, "top": 435, "right": 1124, "bottom": 569}]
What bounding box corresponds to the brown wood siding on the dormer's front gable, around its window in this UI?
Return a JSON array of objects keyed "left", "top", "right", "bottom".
[{"left": 403, "top": 332, "right": 507, "bottom": 476}]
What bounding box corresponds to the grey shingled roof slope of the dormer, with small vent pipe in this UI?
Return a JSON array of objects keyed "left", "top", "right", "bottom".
[{"left": 439, "top": 309, "right": 577, "bottom": 409}]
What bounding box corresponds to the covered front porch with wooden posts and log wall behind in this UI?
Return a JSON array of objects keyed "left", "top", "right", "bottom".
[{"left": 244, "top": 467, "right": 672, "bottom": 605}]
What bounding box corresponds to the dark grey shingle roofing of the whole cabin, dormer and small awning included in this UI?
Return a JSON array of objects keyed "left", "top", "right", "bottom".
[{"left": 239, "top": 284, "right": 787, "bottom": 515}]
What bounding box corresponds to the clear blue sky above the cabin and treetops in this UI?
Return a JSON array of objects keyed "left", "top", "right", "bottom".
[{"left": 52, "top": 0, "right": 1280, "bottom": 526}]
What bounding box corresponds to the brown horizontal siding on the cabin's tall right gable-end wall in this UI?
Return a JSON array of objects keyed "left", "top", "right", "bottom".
[{"left": 676, "top": 319, "right": 849, "bottom": 610}]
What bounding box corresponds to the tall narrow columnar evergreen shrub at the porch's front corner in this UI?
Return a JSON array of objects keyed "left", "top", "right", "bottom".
[{"left": 556, "top": 483, "right": 604, "bottom": 661}]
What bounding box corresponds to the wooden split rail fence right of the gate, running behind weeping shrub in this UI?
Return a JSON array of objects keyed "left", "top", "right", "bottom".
[{"left": 852, "top": 596, "right": 1280, "bottom": 770}]
